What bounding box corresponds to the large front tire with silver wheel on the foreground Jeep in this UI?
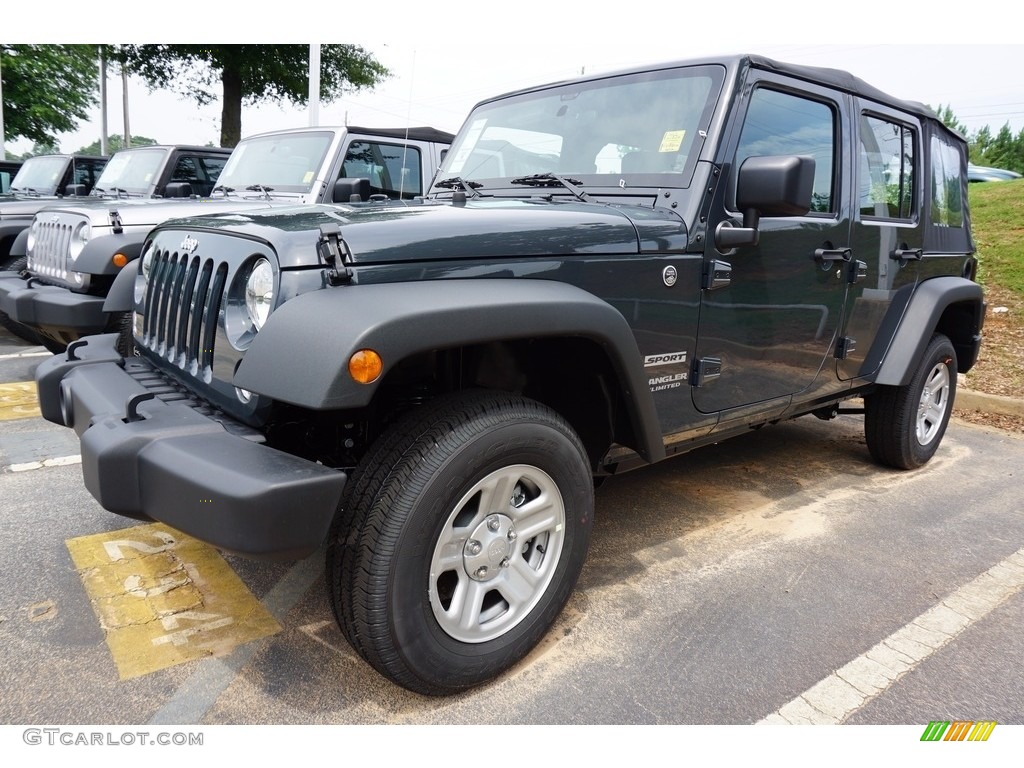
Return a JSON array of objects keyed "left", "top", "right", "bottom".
[{"left": 327, "top": 392, "right": 594, "bottom": 695}]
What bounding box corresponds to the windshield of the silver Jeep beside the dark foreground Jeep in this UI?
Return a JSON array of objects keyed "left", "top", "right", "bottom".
[{"left": 214, "top": 131, "right": 334, "bottom": 197}]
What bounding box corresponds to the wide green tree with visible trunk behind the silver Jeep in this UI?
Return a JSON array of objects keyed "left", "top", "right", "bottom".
[{"left": 110, "top": 45, "right": 390, "bottom": 146}]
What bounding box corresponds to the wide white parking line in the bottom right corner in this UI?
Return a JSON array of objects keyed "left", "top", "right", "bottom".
[{"left": 758, "top": 549, "right": 1024, "bottom": 725}]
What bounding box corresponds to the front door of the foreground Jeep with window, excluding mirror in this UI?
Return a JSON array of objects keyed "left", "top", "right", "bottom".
[{"left": 691, "top": 75, "right": 852, "bottom": 419}]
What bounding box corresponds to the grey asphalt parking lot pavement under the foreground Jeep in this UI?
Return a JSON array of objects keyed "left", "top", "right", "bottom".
[{"left": 0, "top": 325, "right": 1024, "bottom": 737}]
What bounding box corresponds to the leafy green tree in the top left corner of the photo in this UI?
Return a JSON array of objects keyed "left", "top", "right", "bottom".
[{"left": 0, "top": 44, "right": 99, "bottom": 144}]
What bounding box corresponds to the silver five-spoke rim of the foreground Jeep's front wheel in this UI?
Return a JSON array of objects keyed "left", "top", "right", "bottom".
[{"left": 428, "top": 464, "right": 565, "bottom": 643}]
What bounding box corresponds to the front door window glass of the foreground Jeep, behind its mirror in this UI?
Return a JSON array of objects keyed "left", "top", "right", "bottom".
[{"left": 732, "top": 87, "right": 837, "bottom": 213}]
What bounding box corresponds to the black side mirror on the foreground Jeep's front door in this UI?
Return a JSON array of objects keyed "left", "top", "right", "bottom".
[{"left": 715, "top": 155, "right": 814, "bottom": 252}]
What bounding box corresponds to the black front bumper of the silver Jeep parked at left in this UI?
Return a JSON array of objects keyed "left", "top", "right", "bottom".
[{"left": 0, "top": 272, "right": 108, "bottom": 335}]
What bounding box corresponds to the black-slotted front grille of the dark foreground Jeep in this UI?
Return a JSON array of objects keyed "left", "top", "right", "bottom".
[{"left": 142, "top": 251, "right": 227, "bottom": 383}]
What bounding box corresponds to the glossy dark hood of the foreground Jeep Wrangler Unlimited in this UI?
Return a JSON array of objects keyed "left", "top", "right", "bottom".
[{"left": 159, "top": 198, "right": 686, "bottom": 268}]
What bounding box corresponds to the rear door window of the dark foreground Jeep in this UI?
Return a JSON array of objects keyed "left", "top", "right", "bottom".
[{"left": 858, "top": 115, "right": 916, "bottom": 219}]
